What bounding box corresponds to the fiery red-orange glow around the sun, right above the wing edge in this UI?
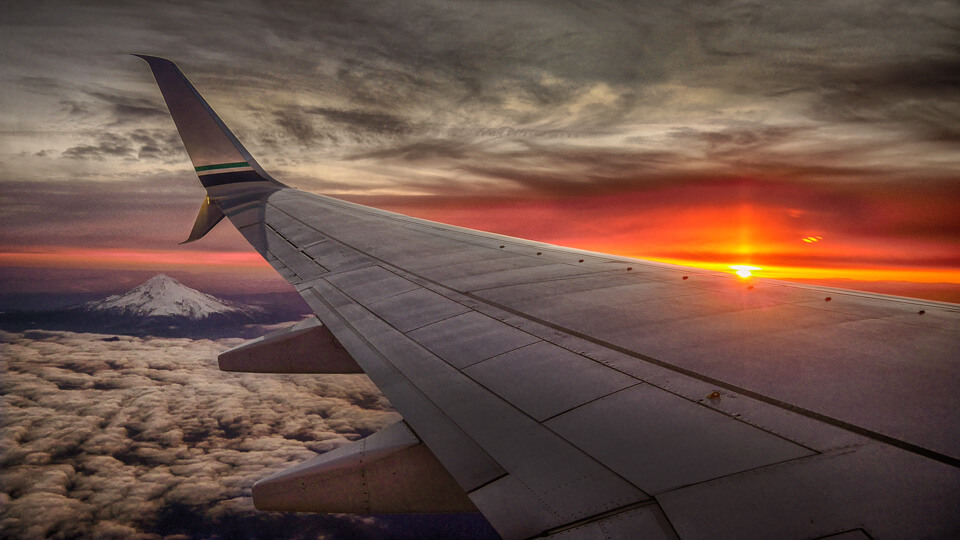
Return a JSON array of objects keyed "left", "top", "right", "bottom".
[{"left": 351, "top": 184, "right": 960, "bottom": 292}]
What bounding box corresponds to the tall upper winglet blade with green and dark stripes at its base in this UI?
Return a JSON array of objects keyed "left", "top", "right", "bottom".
[{"left": 133, "top": 54, "right": 284, "bottom": 190}]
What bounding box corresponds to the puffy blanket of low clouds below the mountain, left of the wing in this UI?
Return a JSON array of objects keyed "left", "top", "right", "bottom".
[{"left": 0, "top": 331, "right": 489, "bottom": 538}]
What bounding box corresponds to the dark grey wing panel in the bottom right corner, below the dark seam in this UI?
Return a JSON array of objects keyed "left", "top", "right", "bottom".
[{"left": 657, "top": 441, "right": 960, "bottom": 540}]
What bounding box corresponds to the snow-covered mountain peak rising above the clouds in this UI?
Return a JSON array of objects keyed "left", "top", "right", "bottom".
[{"left": 81, "top": 274, "right": 263, "bottom": 320}]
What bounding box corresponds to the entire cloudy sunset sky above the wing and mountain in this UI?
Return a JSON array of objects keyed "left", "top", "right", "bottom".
[{"left": 0, "top": 1, "right": 960, "bottom": 302}]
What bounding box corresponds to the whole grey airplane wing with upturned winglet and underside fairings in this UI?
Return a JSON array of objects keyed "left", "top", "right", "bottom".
[{"left": 142, "top": 56, "right": 960, "bottom": 539}]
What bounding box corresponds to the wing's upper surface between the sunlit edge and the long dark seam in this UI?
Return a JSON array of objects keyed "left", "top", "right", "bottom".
[{"left": 258, "top": 192, "right": 960, "bottom": 464}]
